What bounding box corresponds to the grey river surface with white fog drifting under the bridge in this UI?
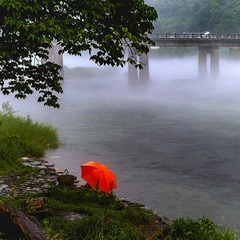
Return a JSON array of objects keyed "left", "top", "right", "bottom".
[{"left": 0, "top": 53, "right": 240, "bottom": 229}]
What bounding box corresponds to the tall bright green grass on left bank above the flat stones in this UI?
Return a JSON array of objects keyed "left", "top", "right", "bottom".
[{"left": 0, "top": 103, "right": 59, "bottom": 174}]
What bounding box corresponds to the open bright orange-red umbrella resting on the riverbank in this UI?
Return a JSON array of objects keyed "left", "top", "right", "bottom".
[{"left": 81, "top": 161, "right": 117, "bottom": 192}]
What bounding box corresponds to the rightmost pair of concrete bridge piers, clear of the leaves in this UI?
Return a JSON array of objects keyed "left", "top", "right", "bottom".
[{"left": 198, "top": 47, "right": 219, "bottom": 79}]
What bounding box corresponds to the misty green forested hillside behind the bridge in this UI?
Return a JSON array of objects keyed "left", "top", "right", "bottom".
[{"left": 145, "top": 0, "right": 240, "bottom": 33}]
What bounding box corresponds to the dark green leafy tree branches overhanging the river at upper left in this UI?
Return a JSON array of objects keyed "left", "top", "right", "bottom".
[{"left": 0, "top": 0, "right": 157, "bottom": 107}]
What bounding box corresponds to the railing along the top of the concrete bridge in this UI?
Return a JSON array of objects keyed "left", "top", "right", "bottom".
[{"left": 149, "top": 33, "right": 240, "bottom": 39}]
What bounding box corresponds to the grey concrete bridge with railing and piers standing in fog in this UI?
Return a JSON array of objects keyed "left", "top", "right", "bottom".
[{"left": 128, "top": 33, "right": 240, "bottom": 82}]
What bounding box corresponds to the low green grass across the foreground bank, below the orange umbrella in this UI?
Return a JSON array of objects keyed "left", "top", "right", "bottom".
[{"left": 0, "top": 186, "right": 240, "bottom": 240}]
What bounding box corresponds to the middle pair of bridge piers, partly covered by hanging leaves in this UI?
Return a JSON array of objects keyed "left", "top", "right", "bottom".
[{"left": 128, "top": 48, "right": 149, "bottom": 85}]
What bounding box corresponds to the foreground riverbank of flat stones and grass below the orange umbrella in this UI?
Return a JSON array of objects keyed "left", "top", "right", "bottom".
[{"left": 0, "top": 158, "right": 240, "bottom": 240}]
